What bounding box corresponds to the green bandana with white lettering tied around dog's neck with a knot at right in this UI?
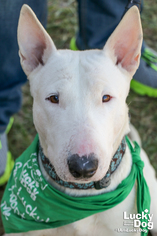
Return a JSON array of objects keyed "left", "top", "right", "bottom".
[{"left": 1, "top": 136, "right": 150, "bottom": 236}]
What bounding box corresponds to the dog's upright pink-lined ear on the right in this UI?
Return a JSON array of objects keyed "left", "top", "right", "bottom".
[{"left": 104, "top": 6, "right": 143, "bottom": 78}]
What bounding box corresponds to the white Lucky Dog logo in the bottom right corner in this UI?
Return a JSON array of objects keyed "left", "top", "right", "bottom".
[{"left": 115, "top": 209, "right": 153, "bottom": 233}]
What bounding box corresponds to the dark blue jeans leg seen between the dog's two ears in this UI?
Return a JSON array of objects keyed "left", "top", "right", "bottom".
[{"left": 76, "top": 0, "right": 144, "bottom": 50}]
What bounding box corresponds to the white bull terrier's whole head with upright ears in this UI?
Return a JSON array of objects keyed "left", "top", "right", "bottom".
[{"left": 18, "top": 5, "right": 142, "bottom": 183}]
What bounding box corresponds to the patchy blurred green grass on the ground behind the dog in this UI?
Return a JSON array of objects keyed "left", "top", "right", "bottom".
[{"left": 0, "top": 0, "right": 157, "bottom": 235}]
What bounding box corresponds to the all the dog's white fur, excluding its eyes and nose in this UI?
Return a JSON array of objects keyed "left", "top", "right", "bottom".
[{"left": 3, "top": 5, "right": 157, "bottom": 236}]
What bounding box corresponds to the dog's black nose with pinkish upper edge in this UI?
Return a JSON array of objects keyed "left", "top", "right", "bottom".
[{"left": 68, "top": 153, "right": 98, "bottom": 178}]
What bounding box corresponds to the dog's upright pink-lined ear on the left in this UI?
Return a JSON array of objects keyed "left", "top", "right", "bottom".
[{"left": 18, "top": 5, "right": 56, "bottom": 76}]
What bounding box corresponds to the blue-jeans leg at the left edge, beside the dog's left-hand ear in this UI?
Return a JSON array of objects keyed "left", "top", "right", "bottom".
[{"left": 0, "top": 0, "right": 47, "bottom": 185}]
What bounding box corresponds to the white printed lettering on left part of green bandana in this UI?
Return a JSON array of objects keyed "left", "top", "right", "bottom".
[{"left": 1, "top": 153, "right": 49, "bottom": 222}]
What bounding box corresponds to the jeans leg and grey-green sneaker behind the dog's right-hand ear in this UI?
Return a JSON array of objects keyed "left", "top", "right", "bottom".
[{"left": 71, "top": 0, "right": 157, "bottom": 97}]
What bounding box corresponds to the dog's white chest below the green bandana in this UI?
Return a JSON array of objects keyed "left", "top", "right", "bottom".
[{"left": 29, "top": 187, "right": 138, "bottom": 236}]
